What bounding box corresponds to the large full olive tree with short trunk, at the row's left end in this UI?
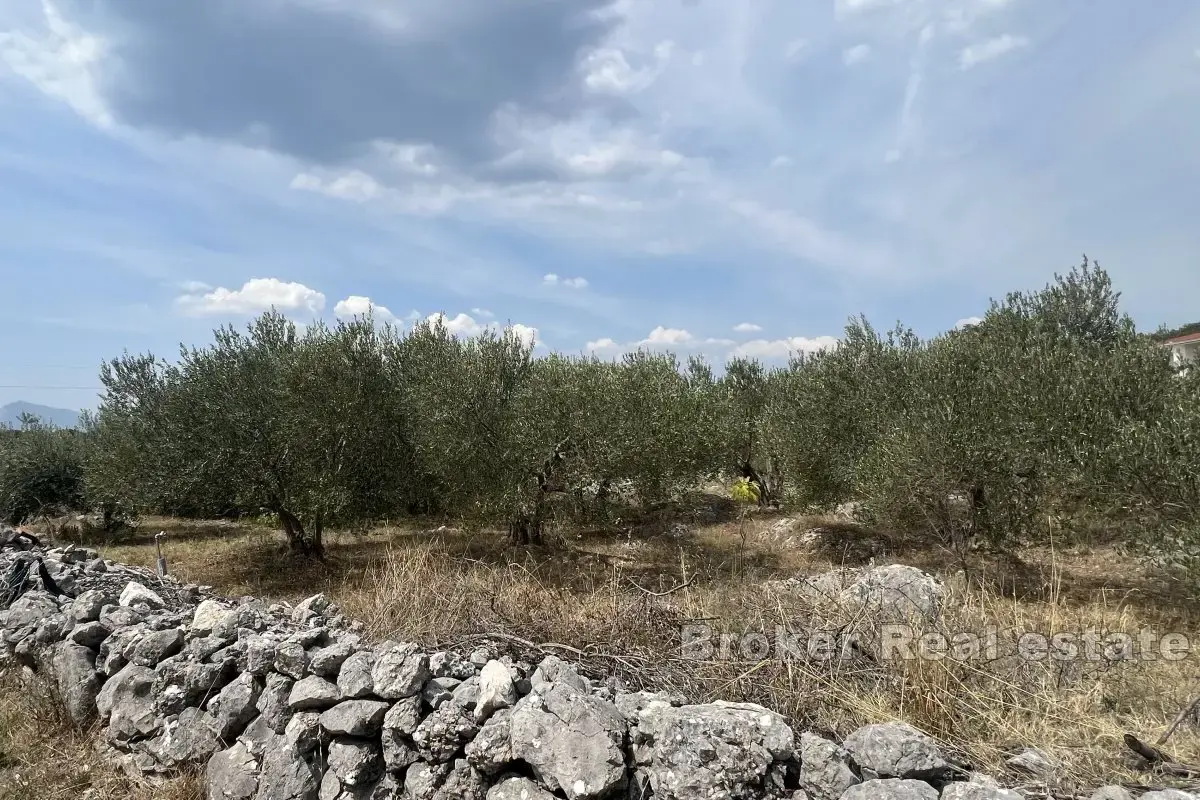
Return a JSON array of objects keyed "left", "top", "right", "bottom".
[{"left": 87, "top": 311, "right": 406, "bottom": 558}]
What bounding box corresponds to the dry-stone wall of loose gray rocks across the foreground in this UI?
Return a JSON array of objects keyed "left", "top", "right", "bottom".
[{"left": 0, "top": 547, "right": 1187, "bottom": 800}]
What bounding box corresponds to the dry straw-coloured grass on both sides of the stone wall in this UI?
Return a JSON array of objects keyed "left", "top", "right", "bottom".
[{"left": 0, "top": 503, "right": 1200, "bottom": 800}]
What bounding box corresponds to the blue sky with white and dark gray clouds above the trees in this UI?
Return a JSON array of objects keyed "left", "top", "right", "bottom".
[{"left": 0, "top": 0, "right": 1200, "bottom": 408}]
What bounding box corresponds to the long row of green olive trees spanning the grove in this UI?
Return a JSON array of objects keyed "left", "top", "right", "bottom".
[{"left": 72, "top": 259, "right": 1200, "bottom": 563}]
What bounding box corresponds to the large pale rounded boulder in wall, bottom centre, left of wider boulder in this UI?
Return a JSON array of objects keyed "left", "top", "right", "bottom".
[{"left": 510, "top": 682, "right": 628, "bottom": 800}]
